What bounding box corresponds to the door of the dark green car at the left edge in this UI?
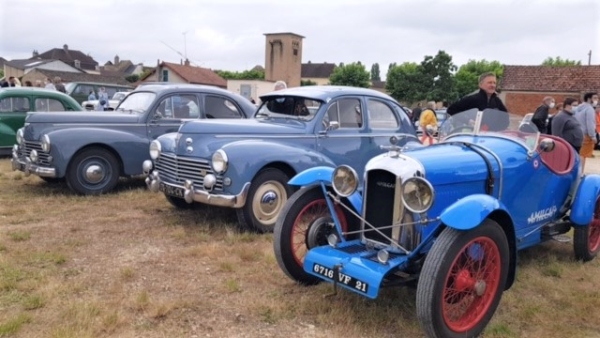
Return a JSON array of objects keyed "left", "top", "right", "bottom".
[{"left": 0, "top": 94, "right": 32, "bottom": 148}]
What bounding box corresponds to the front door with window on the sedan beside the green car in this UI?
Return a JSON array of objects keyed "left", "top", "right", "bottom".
[{"left": 148, "top": 93, "right": 200, "bottom": 140}]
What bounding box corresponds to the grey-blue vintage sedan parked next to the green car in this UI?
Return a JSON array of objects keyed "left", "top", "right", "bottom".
[{"left": 12, "top": 84, "right": 255, "bottom": 194}]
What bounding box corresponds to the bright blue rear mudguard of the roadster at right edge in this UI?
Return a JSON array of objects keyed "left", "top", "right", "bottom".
[{"left": 570, "top": 175, "right": 600, "bottom": 226}]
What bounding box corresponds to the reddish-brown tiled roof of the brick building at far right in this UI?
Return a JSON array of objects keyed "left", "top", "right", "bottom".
[{"left": 498, "top": 65, "right": 600, "bottom": 92}]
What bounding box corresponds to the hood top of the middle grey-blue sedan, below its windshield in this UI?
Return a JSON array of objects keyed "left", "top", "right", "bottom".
[{"left": 179, "top": 119, "right": 306, "bottom": 135}]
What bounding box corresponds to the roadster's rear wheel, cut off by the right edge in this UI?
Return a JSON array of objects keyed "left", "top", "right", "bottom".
[{"left": 573, "top": 198, "right": 600, "bottom": 262}]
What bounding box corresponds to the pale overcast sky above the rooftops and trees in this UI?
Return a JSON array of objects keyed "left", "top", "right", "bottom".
[{"left": 0, "top": 0, "right": 600, "bottom": 76}]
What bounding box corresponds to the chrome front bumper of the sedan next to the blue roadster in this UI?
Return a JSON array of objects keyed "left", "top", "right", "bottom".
[{"left": 145, "top": 170, "right": 250, "bottom": 208}]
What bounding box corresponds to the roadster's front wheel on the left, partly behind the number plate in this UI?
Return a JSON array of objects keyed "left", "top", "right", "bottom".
[{"left": 273, "top": 185, "right": 348, "bottom": 285}]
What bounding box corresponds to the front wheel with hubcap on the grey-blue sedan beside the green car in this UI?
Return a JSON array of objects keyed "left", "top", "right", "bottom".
[{"left": 65, "top": 147, "right": 120, "bottom": 195}]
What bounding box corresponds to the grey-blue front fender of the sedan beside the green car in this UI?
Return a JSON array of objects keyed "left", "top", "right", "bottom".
[{"left": 47, "top": 128, "right": 150, "bottom": 177}]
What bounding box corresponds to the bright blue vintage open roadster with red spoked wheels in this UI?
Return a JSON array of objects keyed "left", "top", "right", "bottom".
[{"left": 274, "top": 110, "right": 600, "bottom": 337}]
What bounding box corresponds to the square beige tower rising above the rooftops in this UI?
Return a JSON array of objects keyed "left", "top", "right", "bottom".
[{"left": 265, "top": 33, "right": 304, "bottom": 87}]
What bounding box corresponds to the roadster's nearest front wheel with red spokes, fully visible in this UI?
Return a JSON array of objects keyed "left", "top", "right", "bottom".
[{"left": 417, "top": 220, "right": 510, "bottom": 338}]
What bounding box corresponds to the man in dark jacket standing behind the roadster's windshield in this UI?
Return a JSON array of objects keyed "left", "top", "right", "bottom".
[{"left": 447, "top": 72, "right": 507, "bottom": 115}]
